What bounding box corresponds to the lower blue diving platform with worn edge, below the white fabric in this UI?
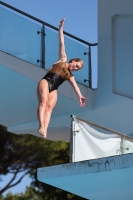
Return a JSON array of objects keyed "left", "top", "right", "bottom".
[{"left": 37, "top": 154, "right": 133, "bottom": 200}]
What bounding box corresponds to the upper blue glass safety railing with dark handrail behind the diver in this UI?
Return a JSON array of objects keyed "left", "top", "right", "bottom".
[{"left": 0, "top": 1, "right": 97, "bottom": 88}]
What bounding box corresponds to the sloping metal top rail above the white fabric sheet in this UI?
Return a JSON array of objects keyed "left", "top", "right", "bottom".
[{"left": 71, "top": 115, "right": 133, "bottom": 141}]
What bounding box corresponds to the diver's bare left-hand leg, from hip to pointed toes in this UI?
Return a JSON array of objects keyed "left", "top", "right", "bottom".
[{"left": 37, "top": 79, "right": 49, "bottom": 136}]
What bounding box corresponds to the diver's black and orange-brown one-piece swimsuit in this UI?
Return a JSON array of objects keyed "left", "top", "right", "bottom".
[{"left": 42, "top": 62, "right": 73, "bottom": 92}]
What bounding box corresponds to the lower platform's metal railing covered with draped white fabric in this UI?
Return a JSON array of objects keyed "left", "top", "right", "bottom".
[{"left": 70, "top": 115, "right": 133, "bottom": 162}]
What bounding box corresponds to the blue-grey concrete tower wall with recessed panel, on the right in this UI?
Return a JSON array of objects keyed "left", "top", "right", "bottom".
[{"left": 78, "top": 0, "right": 133, "bottom": 134}]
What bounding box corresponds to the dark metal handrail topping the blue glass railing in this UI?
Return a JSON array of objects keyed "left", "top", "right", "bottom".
[{"left": 0, "top": 1, "right": 98, "bottom": 46}]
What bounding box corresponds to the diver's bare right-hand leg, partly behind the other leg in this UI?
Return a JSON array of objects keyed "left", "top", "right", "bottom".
[{"left": 44, "top": 90, "right": 57, "bottom": 137}]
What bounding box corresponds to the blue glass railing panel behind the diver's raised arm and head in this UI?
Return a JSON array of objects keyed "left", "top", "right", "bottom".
[{"left": 45, "top": 28, "right": 89, "bottom": 86}]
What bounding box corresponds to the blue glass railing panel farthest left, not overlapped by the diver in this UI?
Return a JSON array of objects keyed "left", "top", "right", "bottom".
[{"left": 0, "top": 7, "right": 42, "bottom": 66}]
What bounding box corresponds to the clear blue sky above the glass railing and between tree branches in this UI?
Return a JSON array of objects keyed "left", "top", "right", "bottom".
[{"left": 2, "top": 0, "right": 98, "bottom": 193}]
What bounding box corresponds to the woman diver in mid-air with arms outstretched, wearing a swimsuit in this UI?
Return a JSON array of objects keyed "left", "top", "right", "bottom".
[{"left": 37, "top": 19, "right": 88, "bottom": 138}]
